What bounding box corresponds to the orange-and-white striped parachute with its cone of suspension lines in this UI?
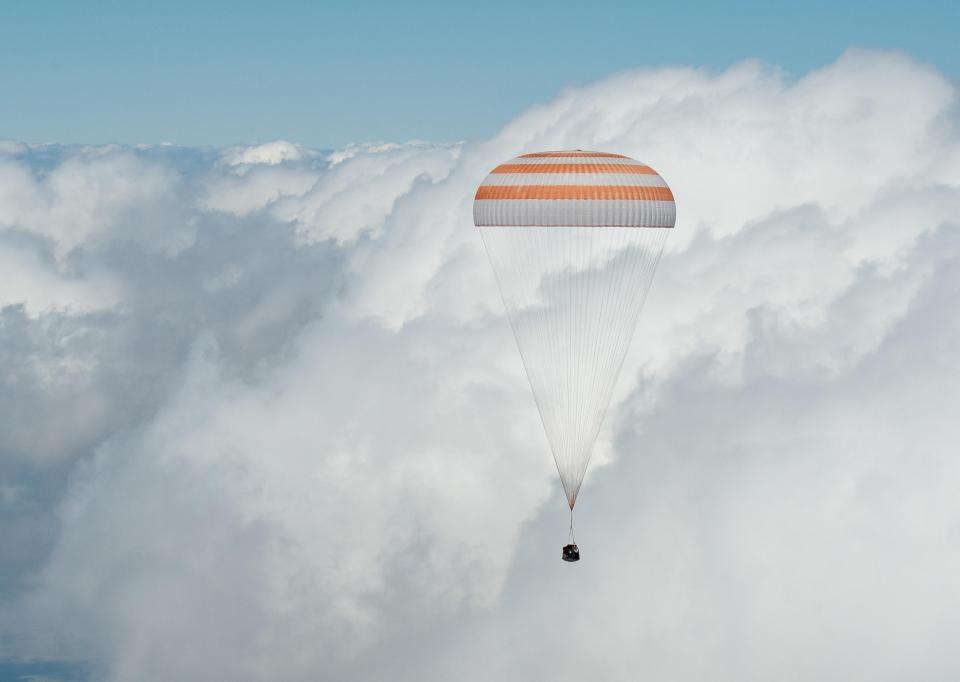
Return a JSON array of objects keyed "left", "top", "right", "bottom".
[{"left": 473, "top": 150, "right": 676, "bottom": 511}]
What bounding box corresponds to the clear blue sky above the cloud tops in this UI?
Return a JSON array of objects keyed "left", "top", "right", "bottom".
[{"left": 0, "top": 0, "right": 960, "bottom": 147}]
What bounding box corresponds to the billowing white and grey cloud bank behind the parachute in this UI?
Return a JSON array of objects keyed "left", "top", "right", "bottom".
[{"left": 0, "top": 51, "right": 960, "bottom": 681}]
